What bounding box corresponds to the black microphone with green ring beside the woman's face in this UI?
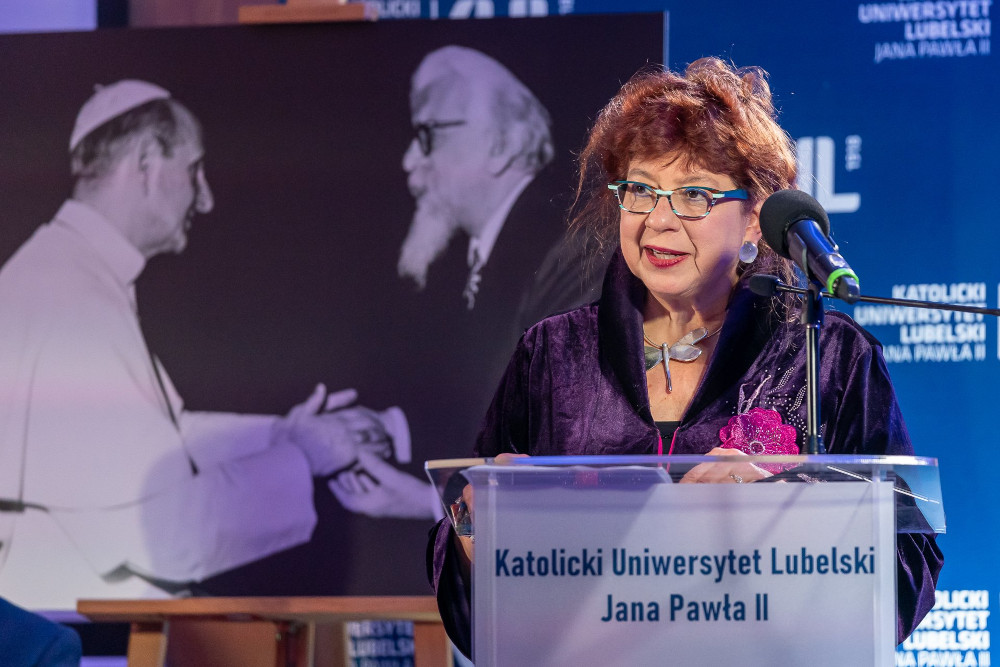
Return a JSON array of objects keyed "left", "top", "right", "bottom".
[{"left": 760, "top": 190, "right": 861, "bottom": 303}]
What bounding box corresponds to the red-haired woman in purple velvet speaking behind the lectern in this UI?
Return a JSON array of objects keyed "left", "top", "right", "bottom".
[{"left": 428, "top": 58, "right": 942, "bottom": 653}]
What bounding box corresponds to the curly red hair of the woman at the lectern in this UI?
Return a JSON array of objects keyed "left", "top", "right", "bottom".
[{"left": 571, "top": 58, "right": 796, "bottom": 288}]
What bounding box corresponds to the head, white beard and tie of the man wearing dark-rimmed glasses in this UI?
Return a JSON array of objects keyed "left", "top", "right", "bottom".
[{"left": 397, "top": 46, "right": 561, "bottom": 310}]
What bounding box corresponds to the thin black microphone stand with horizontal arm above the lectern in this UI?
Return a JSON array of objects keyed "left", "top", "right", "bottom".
[{"left": 750, "top": 275, "right": 1000, "bottom": 454}]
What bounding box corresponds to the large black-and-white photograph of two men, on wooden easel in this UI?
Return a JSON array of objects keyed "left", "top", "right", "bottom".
[{"left": 0, "top": 17, "right": 661, "bottom": 609}]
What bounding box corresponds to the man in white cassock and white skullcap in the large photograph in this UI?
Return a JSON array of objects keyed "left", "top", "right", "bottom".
[{"left": 0, "top": 81, "right": 432, "bottom": 609}]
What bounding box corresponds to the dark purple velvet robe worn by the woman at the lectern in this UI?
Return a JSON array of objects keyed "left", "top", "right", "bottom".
[{"left": 428, "top": 253, "right": 943, "bottom": 654}]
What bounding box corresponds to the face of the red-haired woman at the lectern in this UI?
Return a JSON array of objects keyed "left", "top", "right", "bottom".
[{"left": 620, "top": 157, "right": 760, "bottom": 310}]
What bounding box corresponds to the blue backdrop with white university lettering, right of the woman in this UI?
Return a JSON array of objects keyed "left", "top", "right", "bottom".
[{"left": 668, "top": 1, "right": 1000, "bottom": 665}]
